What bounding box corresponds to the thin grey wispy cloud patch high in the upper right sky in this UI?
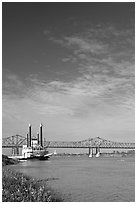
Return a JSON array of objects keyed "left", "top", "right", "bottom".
[{"left": 50, "top": 26, "right": 135, "bottom": 71}]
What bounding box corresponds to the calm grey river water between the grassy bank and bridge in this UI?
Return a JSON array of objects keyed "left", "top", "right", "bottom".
[{"left": 9, "top": 156, "right": 135, "bottom": 202}]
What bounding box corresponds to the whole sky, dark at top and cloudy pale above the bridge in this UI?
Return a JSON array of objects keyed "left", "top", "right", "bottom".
[{"left": 2, "top": 2, "right": 135, "bottom": 142}]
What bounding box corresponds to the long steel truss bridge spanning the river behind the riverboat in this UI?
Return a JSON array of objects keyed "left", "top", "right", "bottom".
[{"left": 2, "top": 135, "right": 135, "bottom": 154}]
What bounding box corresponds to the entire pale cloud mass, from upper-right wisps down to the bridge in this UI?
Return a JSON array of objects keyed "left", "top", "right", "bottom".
[{"left": 3, "top": 23, "right": 134, "bottom": 138}]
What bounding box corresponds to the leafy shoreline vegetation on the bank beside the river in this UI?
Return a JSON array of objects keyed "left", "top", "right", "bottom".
[{"left": 2, "top": 155, "right": 63, "bottom": 202}]
